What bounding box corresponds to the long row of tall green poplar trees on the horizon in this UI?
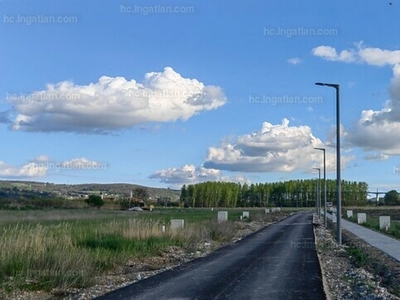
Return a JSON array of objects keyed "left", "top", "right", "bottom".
[{"left": 180, "top": 179, "right": 368, "bottom": 207}]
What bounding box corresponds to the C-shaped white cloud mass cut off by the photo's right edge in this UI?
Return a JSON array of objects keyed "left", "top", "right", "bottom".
[{"left": 312, "top": 43, "right": 400, "bottom": 157}]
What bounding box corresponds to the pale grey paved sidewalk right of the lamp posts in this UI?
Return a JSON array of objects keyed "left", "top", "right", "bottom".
[{"left": 327, "top": 214, "right": 400, "bottom": 261}]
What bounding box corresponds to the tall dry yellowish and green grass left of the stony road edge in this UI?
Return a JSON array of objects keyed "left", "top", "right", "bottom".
[{"left": 0, "top": 210, "right": 235, "bottom": 296}]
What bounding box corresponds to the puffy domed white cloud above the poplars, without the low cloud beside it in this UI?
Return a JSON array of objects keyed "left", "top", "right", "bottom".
[{"left": 204, "top": 119, "right": 351, "bottom": 172}]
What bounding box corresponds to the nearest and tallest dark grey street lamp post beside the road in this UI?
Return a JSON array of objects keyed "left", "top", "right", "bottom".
[{"left": 315, "top": 82, "right": 342, "bottom": 245}]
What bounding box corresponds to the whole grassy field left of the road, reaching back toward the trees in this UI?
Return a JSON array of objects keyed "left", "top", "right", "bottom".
[{"left": 0, "top": 209, "right": 282, "bottom": 291}]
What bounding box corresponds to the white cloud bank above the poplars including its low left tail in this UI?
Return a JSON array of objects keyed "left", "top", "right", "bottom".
[{"left": 149, "top": 119, "right": 354, "bottom": 187}]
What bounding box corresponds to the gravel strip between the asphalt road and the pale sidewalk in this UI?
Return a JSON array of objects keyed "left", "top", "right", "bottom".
[{"left": 314, "top": 220, "right": 400, "bottom": 300}]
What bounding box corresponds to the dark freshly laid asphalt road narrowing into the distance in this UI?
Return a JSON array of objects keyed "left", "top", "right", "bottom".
[{"left": 98, "top": 212, "right": 325, "bottom": 300}]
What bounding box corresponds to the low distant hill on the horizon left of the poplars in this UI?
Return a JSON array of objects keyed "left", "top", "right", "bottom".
[{"left": 0, "top": 180, "right": 180, "bottom": 201}]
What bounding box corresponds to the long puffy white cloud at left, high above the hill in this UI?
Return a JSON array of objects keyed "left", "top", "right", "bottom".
[{"left": 7, "top": 67, "right": 226, "bottom": 133}]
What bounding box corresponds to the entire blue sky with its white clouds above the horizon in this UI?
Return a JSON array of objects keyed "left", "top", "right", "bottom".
[{"left": 0, "top": 0, "right": 400, "bottom": 190}]
